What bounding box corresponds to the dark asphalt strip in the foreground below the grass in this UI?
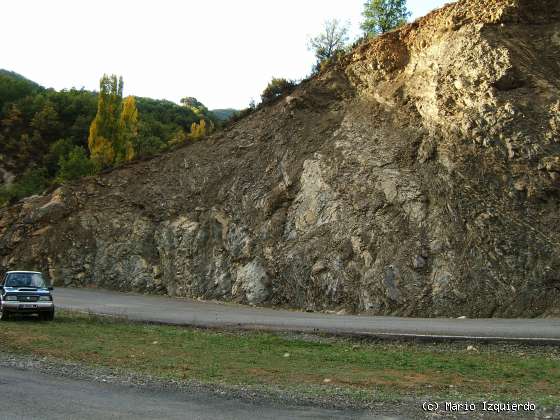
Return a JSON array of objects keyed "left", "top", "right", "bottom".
[{"left": 0, "top": 367, "right": 384, "bottom": 420}]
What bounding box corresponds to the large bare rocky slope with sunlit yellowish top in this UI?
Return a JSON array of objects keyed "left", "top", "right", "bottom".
[{"left": 0, "top": 0, "right": 560, "bottom": 317}]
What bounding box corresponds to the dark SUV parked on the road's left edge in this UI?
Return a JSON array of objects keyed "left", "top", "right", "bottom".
[{"left": 0, "top": 271, "right": 54, "bottom": 321}]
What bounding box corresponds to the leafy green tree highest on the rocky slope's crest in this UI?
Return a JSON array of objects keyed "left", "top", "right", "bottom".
[{"left": 361, "top": 0, "right": 410, "bottom": 36}]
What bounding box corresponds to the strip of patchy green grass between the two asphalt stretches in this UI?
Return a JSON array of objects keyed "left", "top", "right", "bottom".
[{"left": 0, "top": 312, "right": 560, "bottom": 405}]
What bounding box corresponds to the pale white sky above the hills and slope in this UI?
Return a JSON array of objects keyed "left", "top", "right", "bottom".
[{"left": 0, "top": 0, "right": 450, "bottom": 109}]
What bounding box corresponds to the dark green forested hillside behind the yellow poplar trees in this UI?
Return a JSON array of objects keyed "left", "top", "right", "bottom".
[{"left": 0, "top": 69, "right": 218, "bottom": 205}]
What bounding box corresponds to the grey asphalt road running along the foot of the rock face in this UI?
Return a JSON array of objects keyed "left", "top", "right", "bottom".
[{"left": 54, "top": 288, "right": 560, "bottom": 344}]
